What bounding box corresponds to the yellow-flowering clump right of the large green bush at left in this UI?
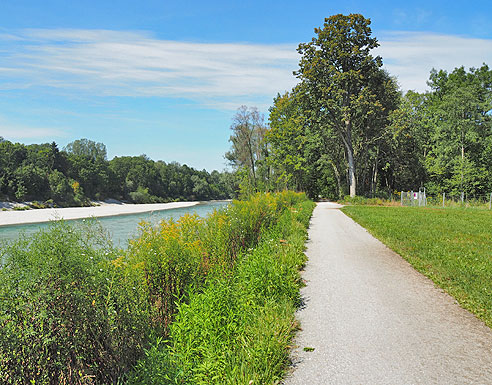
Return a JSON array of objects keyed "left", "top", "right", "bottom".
[{"left": 125, "top": 215, "right": 208, "bottom": 335}]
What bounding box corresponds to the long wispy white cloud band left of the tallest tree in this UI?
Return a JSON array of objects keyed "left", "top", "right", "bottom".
[{"left": 0, "top": 30, "right": 298, "bottom": 106}]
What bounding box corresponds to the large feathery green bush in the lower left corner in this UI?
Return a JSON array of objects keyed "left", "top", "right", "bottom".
[{"left": 0, "top": 222, "right": 145, "bottom": 384}]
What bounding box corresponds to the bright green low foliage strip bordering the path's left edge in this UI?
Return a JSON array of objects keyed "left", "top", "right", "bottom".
[{"left": 129, "top": 193, "right": 314, "bottom": 385}]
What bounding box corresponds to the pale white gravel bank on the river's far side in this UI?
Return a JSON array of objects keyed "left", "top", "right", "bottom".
[{"left": 0, "top": 201, "right": 200, "bottom": 226}]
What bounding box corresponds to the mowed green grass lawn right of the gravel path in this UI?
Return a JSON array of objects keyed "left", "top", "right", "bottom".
[{"left": 342, "top": 206, "right": 492, "bottom": 327}]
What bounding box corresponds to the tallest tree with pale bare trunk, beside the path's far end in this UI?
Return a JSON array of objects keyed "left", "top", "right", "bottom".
[{"left": 295, "top": 14, "right": 397, "bottom": 196}]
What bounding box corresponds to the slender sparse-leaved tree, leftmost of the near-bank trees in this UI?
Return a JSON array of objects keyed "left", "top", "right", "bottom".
[{"left": 225, "top": 106, "right": 267, "bottom": 191}]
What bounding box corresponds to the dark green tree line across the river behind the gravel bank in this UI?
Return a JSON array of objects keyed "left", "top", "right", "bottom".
[{"left": 0, "top": 137, "right": 235, "bottom": 205}]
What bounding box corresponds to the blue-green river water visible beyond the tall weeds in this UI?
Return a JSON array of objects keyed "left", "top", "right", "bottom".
[{"left": 0, "top": 201, "right": 229, "bottom": 248}]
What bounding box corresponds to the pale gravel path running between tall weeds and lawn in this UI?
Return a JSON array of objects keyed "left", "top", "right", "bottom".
[{"left": 285, "top": 203, "right": 492, "bottom": 385}]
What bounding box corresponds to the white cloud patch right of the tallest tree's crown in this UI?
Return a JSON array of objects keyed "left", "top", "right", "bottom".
[{"left": 375, "top": 32, "right": 492, "bottom": 92}]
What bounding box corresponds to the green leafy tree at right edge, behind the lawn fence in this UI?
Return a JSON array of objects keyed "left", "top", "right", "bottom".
[{"left": 427, "top": 65, "right": 492, "bottom": 195}]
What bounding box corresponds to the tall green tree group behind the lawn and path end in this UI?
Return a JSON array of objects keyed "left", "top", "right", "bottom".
[{"left": 226, "top": 14, "right": 492, "bottom": 198}]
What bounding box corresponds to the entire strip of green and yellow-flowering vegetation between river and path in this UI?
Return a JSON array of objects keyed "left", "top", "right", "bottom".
[{"left": 0, "top": 192, "right": 314, "bottom": 384}]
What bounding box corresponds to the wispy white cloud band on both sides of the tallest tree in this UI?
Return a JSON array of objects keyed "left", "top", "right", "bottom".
[{"left": 0, "top": 29, "right": 492, "bottom": 104}]
